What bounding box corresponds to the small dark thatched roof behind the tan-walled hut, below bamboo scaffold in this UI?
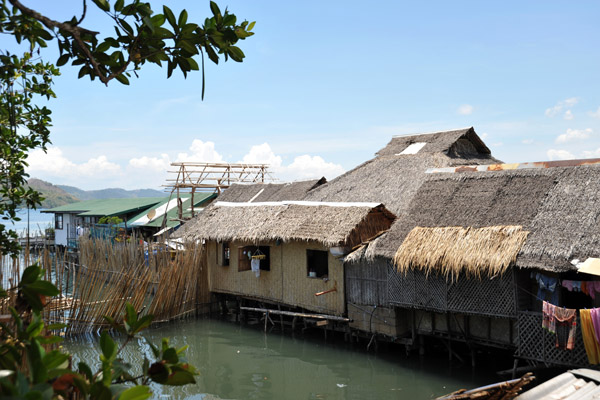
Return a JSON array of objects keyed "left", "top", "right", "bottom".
[{"left": 219, "top": 178, "right": 327, "bottom": 202}]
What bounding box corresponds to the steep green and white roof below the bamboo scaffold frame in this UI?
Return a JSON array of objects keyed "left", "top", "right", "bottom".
[{"left": 127, "top": 193, "right": 217, "bottom": 228}]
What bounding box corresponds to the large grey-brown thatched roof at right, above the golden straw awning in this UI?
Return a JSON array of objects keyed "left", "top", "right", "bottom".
[{"left": 360, "top": 165, "right": 600, "bottom": 272}]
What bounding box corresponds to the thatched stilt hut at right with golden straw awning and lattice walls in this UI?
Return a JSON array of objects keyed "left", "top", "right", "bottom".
[{"left": 350, "top": 161, "right": 600, "bottom": 365}]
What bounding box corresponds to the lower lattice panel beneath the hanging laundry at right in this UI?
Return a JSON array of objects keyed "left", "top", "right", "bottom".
[{"left": 517, "top": 312, "right": 590, "bottom": 367}]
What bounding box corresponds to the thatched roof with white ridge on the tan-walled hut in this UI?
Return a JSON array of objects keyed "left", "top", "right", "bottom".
[{"left": 175, "top": 201, "right": 395, "bottom": 247}]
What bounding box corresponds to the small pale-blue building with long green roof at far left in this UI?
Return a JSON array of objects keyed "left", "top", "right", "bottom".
[{"left": 42, "top": 197, "right": 163, "bottom": 247}]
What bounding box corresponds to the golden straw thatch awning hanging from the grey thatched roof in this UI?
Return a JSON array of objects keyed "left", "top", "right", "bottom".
[{"left": 394, "top": 226, "right": 529, "bottom": 280}]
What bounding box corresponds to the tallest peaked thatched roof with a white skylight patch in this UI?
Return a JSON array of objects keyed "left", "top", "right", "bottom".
[{"left": 305, "top": 128, "right": 498, "bottom": 217}]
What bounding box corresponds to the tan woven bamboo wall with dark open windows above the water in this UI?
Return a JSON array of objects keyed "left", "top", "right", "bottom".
[{"left": 207, "top": 242, "right": 345, "bottom": 315}]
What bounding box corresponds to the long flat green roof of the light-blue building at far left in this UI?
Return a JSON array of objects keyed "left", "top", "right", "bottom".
[{"left": 44, "top": 197, "right": 164, "bottom": 217}]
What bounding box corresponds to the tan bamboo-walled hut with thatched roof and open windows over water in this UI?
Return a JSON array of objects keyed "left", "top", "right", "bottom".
[{"left": 179, "top": 201, "right": 395, "bottom": 316}]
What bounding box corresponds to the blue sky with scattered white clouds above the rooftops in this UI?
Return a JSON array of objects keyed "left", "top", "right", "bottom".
[{"left": 5, "top": 0, "right": 600, "bottom": 189}]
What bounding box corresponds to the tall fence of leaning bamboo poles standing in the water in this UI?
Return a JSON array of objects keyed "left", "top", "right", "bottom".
[{"left": 0, "top": 238, "right": 210, "bottom": 335}]
